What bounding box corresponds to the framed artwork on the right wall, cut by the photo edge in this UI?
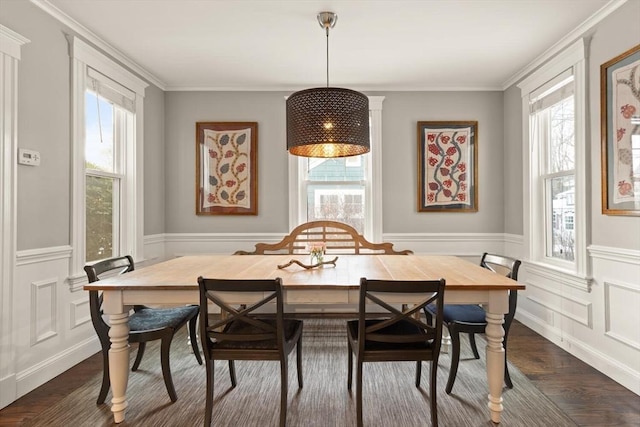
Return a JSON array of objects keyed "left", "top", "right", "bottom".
[{"left": 600, "top": 45, "right": 640, "bottom": 216}]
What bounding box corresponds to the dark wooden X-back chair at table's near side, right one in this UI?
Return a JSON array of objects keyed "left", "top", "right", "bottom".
[{"left": 347, "top": 278, "right": 445, "bottom": 427}]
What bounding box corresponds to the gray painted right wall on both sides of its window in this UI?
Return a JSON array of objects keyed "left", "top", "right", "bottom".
[{"left": 504, "top": 0, "right": 640, "bottom": 250}]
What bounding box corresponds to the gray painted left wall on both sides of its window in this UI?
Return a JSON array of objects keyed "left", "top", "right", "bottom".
[{"left": 0, "top": 0, "right": 165, "bottom": 250}]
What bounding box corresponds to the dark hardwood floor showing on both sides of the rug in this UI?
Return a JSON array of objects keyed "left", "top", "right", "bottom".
[{"left": 0, "top": 321, "right": 640, "bottom": 426}]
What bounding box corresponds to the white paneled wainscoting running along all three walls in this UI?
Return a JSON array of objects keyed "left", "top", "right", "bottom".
[{"left": 0, "top": 233, "right": 640, "bottom": 408}]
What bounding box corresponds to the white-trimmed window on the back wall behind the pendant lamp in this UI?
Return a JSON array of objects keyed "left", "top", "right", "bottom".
[{"left": 289, "top": 97, "right": 384, "bottom": 241}]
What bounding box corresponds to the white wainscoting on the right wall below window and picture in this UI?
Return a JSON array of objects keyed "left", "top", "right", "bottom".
[{"left": 516, "top": 246, "right": 640, "bottom": 395}]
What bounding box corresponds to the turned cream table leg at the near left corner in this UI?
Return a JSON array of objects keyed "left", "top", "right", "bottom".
[{"left": 109, "top": 312, "right": 129, "bottom": 423}]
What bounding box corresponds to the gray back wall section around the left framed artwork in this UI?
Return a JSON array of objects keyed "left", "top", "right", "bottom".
[{"left": 165, "top": 92, "right": 289, "bottom": 234}]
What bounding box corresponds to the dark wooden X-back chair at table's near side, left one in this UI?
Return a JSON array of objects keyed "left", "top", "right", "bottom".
[{"left": 198, "top": 277, "right": 302, "bottom": 427}]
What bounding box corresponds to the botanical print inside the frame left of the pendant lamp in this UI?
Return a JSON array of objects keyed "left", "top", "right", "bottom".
[{"left": 202, "top": 128, "right": 251, "bottom": 209}]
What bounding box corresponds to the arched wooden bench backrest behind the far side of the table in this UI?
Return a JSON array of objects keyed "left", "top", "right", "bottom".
[{"left": 235, "top": 221, "right": 413, "bottom": 255}]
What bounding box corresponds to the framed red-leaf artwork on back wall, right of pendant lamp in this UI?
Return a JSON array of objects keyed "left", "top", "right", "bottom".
[{"left": 418, "top": 121, "right": 478, "bottom": 212}]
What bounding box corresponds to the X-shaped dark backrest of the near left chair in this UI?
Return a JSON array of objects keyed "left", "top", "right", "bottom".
[{"left": 198, "top": 277, "right": 284, "bottom": 354}]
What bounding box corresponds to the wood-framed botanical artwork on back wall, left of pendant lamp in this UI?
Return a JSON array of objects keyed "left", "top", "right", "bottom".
[{"left": 196, "top": 122, "right": 258, "bottom": 215}]
